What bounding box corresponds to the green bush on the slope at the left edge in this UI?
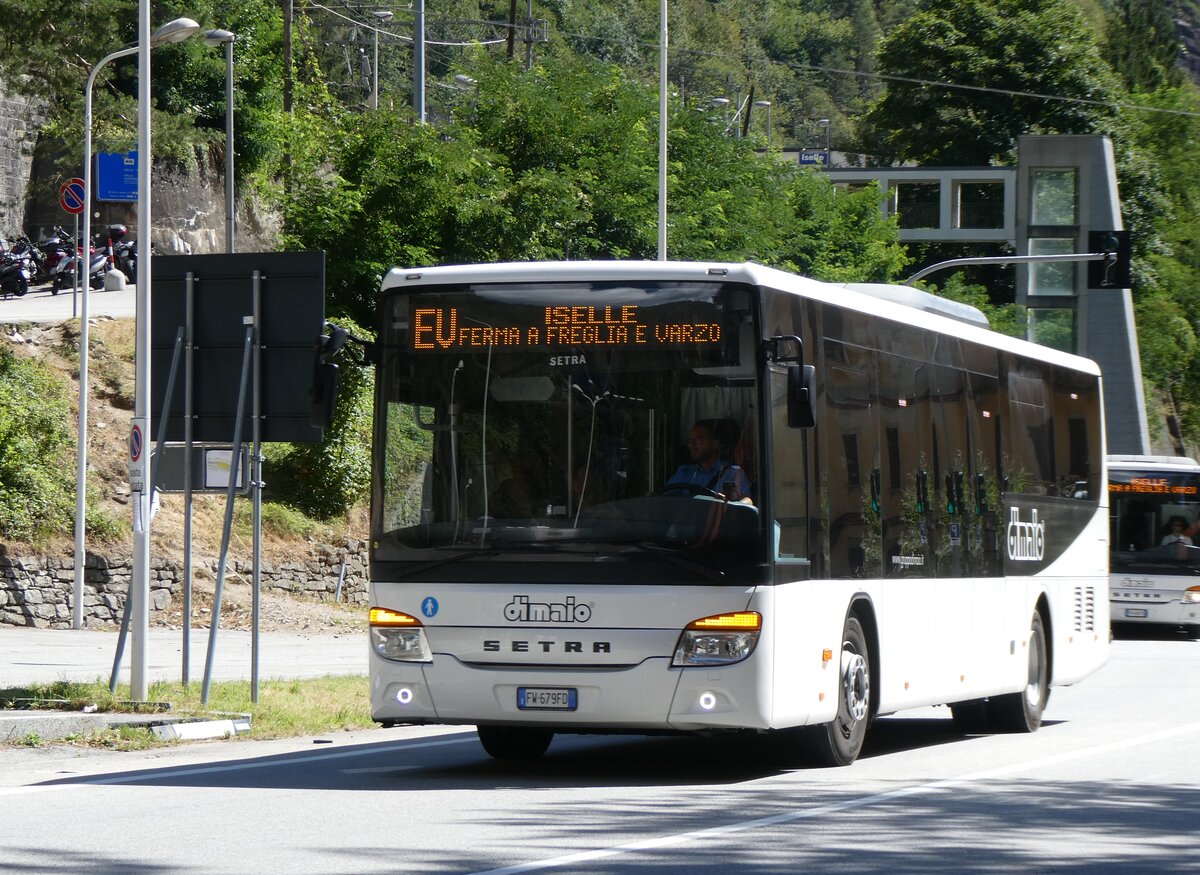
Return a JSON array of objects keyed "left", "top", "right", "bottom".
[{"left": 0, "top": 347, "right": 74, "bottom": 541}]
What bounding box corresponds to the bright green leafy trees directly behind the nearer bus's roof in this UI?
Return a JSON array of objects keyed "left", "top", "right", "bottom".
[{"left": 284, "top": 53, "right": 905, "bottom": 323}]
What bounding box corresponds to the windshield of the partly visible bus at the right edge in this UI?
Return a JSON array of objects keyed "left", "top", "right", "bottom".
[{"left": 1109, "top": 468, "right": 1200, "bottom": 575}]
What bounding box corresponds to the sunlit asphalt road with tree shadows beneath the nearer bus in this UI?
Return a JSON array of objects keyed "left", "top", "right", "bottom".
[{"left": 0, "top": 636, "right": 1200, "bottom": 875}]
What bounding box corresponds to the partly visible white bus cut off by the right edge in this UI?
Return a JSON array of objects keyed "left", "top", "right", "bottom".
[{"left": 1109, "top": 456, "right": 1200, "bottom": 637}]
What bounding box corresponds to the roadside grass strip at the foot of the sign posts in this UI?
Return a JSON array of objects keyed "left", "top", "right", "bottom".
[{"left": 0, "top": 676, "right": 374, "bottom": 750}]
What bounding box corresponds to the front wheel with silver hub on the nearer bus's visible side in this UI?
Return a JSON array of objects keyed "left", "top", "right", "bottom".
[{"left": 803, "top": 616, "right": 871, "bottom": 766}]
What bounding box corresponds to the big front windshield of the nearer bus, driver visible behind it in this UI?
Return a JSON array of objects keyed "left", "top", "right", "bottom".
[{"left": 372, "top": 282, "right": 763, "bottom": 582}]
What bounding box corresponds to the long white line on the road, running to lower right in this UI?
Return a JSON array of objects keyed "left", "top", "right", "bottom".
[{"left": 463, "top": 723, "right": 1200, "bottom": 875}]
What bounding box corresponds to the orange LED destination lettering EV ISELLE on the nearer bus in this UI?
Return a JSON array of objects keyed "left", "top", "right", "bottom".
[{"left": 412, "top": 304, "right": 721, "bottom": 352}]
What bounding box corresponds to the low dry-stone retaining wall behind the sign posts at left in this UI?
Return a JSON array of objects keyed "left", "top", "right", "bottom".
[{"left": 0, "top": 541, "right": 367, "bottom": 629}]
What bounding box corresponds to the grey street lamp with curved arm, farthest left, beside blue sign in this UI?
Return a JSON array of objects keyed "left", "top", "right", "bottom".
[{"left": 71, "top": 18, "right": 200, "bottom": 629}]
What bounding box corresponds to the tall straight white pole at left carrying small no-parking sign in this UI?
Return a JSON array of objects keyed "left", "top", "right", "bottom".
[{"left": 130, "top": 0, "right": 154, "bottom": 701}]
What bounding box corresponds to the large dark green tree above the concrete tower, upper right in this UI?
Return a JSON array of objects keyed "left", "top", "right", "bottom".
[{"left": 865, "top": 0, "right": 1120, "bottom": 166}]
